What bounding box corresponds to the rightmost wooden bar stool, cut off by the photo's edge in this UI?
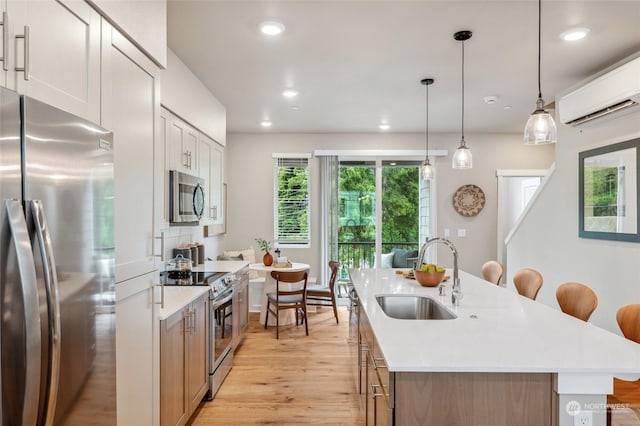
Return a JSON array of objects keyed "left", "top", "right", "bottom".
[{"left": 607, "top": 304, "right": 640, "bottom": 426}]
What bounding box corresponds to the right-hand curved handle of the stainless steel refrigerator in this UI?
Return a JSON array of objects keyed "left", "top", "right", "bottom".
[{"left": 28, "top": 200, "right": 60, "bottom": 425}]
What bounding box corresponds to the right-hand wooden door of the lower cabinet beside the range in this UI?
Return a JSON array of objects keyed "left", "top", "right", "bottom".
[{"left": 186, "top": 295, "right": 209, "bottom": 413}]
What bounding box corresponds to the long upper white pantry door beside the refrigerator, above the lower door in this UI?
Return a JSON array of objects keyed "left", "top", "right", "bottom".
[{"left": 102, "top": 22, "right": 160, "bottom": 282}]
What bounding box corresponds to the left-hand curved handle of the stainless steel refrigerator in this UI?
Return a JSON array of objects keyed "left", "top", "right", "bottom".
[{"left": 2, "top": 200, "right": 42, "bottom": 425}]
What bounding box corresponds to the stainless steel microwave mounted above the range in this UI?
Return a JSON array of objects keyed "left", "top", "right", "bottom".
[{"left": 169, "top": 170, "right": 204, "bottom": 225}]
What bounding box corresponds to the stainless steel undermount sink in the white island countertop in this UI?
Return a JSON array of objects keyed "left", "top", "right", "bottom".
[{"left": 376, "top": 295, "right": 457, "bottom": 320}]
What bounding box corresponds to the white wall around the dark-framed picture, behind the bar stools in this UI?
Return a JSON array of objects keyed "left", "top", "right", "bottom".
[{"left": 506, "top": 109, "right": 640, "bottom": 333}]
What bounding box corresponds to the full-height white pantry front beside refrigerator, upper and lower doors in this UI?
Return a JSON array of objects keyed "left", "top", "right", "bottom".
[{"left": 102, "top": 21, "right": 160, "bottom": 425}]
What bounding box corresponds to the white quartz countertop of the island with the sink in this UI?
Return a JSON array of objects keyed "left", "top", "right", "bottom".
[{"left": 349, "top": 269, "right": 640, "bottom": 376}]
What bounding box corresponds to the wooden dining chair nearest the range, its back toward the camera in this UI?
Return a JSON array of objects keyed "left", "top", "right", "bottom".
[{"left": 264, "top": 271, "right": 309, "bottom": 339}]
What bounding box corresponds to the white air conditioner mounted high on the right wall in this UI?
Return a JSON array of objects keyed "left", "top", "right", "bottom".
[{"left": 559, "top": 58, "right": 640, "bottom": 126}]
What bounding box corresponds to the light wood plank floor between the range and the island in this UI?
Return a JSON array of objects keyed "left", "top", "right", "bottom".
[{"left": 189, "top": 307, "right": 364, "bottom": 426}]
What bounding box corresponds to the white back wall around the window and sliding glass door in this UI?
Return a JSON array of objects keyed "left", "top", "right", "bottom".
[{"left": 220, "top": 133, "right": 553, "bottom": 276}]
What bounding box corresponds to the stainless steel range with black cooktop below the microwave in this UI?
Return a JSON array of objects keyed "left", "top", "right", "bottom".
[{"left": 160, "top": 272, "right": 236, "bottom": 400}]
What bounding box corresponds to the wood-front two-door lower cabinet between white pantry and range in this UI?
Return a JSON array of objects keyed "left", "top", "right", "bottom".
[{"left": 160, "top": 294, "right": 209, "bottom": 426}]
